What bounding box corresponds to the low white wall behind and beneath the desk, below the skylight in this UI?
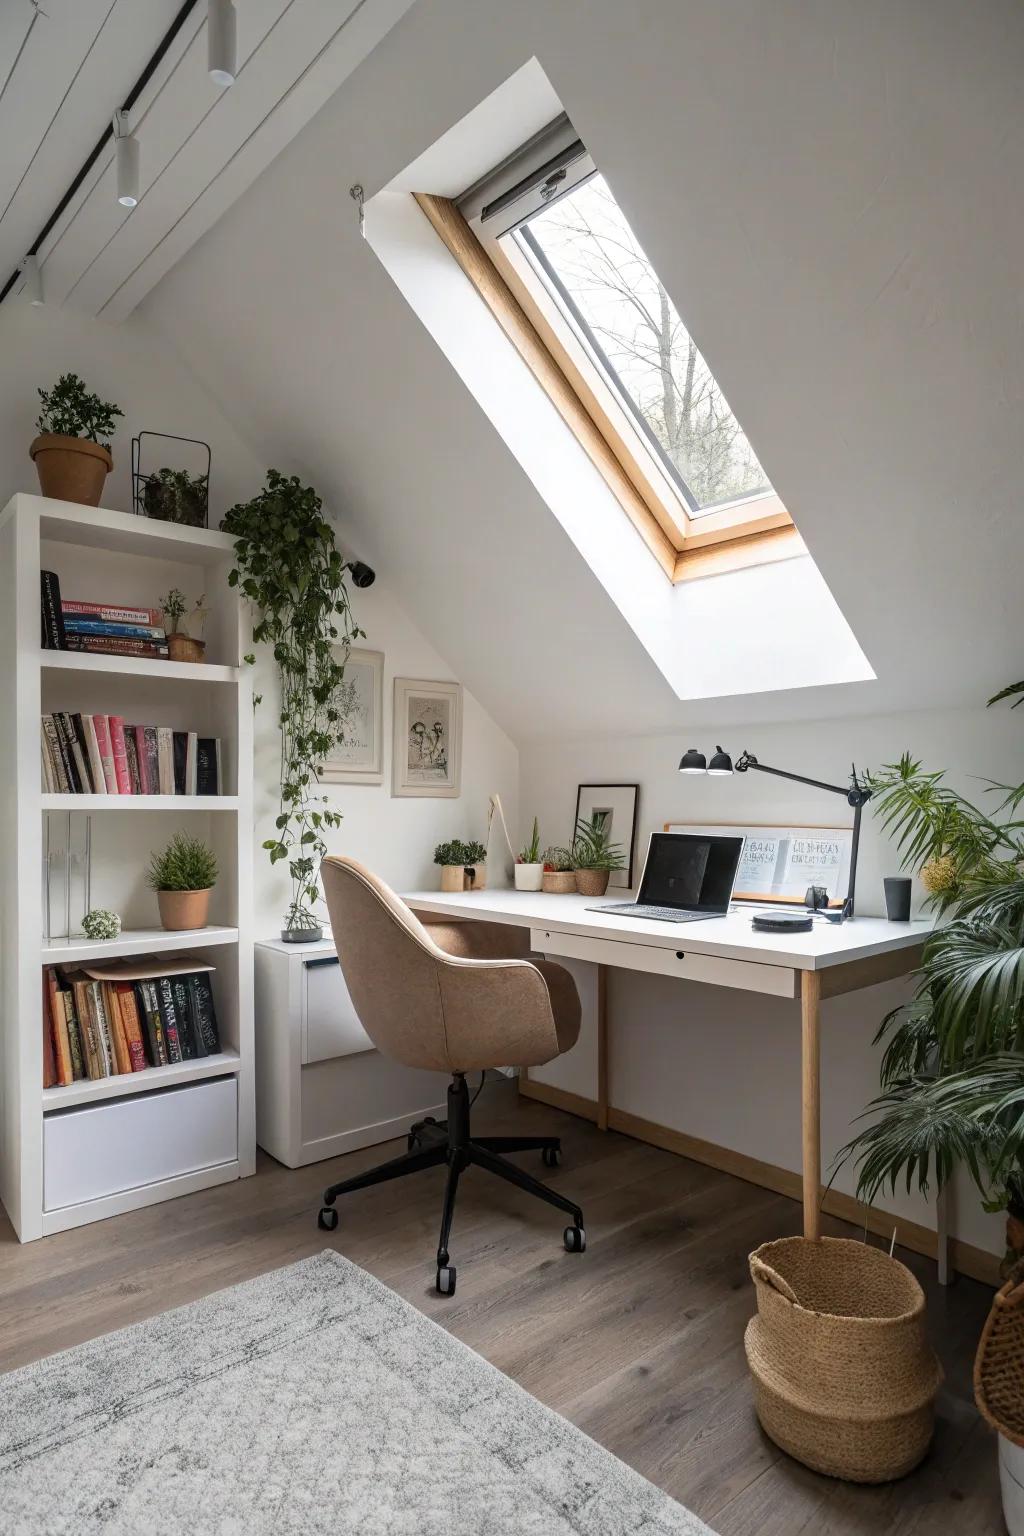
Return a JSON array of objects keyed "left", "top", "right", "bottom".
[{"left": 520, "top": 706, "right": 1024, "bottom": 1253}]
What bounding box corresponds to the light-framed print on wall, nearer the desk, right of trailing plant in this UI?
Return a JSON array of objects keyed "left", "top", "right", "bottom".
[{"left": 391, "top": 677, "right": 462, "bottom": 800}]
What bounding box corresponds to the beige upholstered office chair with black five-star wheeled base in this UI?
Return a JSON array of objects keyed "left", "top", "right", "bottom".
[{"left": 318, "top": 859, "right": 586, "bottom": 1296}]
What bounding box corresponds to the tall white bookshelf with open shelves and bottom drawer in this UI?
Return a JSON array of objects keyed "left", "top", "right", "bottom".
[{"left": 0, "top": 495, "right": 255, "bottom": 1241}]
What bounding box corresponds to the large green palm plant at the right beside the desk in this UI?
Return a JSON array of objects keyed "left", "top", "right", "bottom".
[{"left": 837, "top": 684, "right": 1024, "bottom": 1271}]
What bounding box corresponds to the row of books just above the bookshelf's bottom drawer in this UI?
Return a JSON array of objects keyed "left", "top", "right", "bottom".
[{"left": 43, "top": 955, "right": 221, "bottom": 1087}]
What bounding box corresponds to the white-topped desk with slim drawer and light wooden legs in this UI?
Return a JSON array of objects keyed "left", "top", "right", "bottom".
[{"left": 404, "top": 891, "right": 933, "bottom": 1238}]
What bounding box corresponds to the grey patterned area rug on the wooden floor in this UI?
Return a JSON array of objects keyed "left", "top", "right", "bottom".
[{"left": 0, "top": 1250, "right": 721, "bottom": 1536}]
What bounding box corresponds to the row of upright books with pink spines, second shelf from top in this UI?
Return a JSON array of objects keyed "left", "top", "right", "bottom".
[{"left": 41, "top": 710, "right": 223, "bottom": 794}]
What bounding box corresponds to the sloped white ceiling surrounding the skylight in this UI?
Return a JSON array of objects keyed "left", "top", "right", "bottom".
[{"left": 146, "top": 0, "right": 1024, "bottom": 739}]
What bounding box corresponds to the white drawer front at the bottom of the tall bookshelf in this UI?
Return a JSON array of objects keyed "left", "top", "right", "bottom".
[{"left": 43, "top": 1077, "right": 238, "bottom": 1210}]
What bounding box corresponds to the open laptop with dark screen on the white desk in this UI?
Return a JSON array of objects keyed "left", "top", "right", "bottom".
[{"left": 588, "top": 833, "right": 743, "bottom": 923}]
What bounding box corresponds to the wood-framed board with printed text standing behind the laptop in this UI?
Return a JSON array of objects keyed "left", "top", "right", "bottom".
[{"left": 665, "top": 822, "right": 854, "bottom": 906}]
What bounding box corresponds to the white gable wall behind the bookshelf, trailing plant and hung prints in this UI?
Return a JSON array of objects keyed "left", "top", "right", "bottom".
[{"left": 0, "top": 300, "right": 517, "bottom": 937}]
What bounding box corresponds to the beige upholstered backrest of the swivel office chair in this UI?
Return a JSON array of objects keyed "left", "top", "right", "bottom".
[{"left": 321, "top": 857, "right": 559, "bottom": 1072}]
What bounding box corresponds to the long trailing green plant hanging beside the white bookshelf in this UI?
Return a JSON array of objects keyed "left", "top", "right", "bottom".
[{"left": 221, "top": 470, "right": 364, "bottom": 931}]
